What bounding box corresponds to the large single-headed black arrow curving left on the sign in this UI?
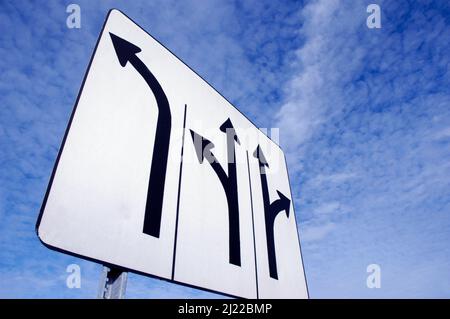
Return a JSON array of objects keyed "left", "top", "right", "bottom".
[{"left": 109, "top": 33, "right": 172, "bottom": 238}]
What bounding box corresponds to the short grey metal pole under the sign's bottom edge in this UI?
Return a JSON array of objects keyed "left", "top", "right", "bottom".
[{"left": 97, "top": 266, "right": 128, "bottom": 299}]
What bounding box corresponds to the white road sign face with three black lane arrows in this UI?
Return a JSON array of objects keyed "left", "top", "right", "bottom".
[{"left": 36, "top": 10, "right": 308, "bottom": 298}]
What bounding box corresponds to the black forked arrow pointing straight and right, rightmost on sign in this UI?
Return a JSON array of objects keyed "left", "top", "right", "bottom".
[{"left": 253, "top": 145, "right": 291, "bottom": 279}]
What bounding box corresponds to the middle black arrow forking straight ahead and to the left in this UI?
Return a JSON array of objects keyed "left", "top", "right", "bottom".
[{"left": 191, "top": 119, "right": 241, "bottom": 266}]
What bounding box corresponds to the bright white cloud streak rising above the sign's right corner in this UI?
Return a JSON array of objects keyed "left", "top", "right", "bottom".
[{"left": 277, "top": 0, "right": 364, "bottom": 159}]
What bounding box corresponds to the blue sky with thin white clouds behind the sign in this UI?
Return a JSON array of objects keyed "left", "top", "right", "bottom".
[{"left": 0, "top": 0, "right": 450, "bottom": 298}]
